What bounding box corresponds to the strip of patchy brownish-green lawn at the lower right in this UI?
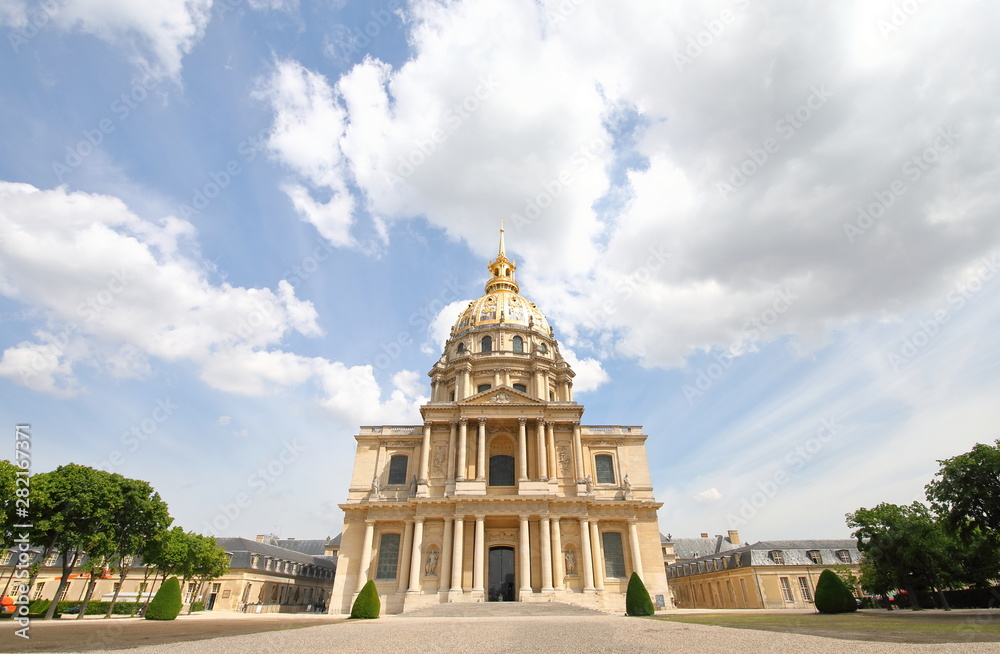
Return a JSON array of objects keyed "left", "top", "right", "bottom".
[{"left": 658, "top": 611, "right": 1000, "bottom": 643}]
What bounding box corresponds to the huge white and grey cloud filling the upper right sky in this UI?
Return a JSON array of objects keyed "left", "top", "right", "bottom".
[{"left": 254, "top": 0, "right": 1000, "bottom": 376}]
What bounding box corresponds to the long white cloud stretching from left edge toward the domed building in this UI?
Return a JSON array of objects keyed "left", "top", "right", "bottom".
[{"left": 0, "top": 182, "right": 420, "bottom": 421}]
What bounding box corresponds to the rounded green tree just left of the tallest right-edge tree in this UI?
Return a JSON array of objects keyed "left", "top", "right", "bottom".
[{"left": 847, "top": 502, "right": 961, "bottom": 610}]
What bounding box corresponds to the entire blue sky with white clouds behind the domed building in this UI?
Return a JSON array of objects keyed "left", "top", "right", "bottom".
[{"left": 0, "top": 0, "right": 1000, "bottom": 540}]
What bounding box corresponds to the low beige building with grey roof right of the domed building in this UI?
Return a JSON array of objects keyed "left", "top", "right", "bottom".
[{"left": 666, "top": 539, "right": 861, "bottom": 609}]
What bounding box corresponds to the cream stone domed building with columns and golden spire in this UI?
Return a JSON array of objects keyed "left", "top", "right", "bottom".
[{"left": 330, "top": 229, "right": 669, "bottom": 613}]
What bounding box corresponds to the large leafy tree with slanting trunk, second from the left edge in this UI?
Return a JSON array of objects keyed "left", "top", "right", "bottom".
[{"left": 31, "top": 463, "right": 121, "bottom": 619}]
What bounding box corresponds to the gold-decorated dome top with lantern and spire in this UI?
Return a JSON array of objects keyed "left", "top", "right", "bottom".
[{"left": 452, "top": 226, "right": 552, "bottom": 336}]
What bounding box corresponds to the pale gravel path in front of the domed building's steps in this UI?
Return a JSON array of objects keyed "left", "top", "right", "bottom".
[{"left": 80, "top": 616, "right": 1000, "bottom": 654}]
